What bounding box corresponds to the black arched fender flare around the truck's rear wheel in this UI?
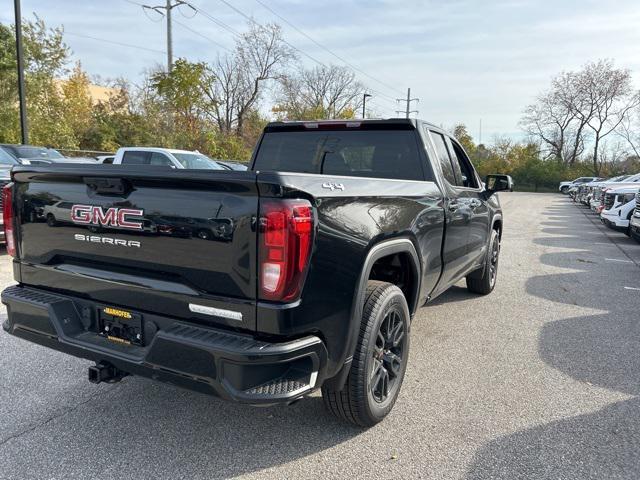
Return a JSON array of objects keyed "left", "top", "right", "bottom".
[{"left": 327, "top": 238, "right": 422, "bottom": 390}]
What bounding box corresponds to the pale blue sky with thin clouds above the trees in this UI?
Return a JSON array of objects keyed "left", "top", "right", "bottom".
[{"left": 0, "top": 0, "right": 640, "bottom": 143}]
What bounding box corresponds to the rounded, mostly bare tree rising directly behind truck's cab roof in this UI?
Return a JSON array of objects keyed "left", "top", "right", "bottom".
[{"left": 274, "top": 65, "right": 366, "bottom": 120}]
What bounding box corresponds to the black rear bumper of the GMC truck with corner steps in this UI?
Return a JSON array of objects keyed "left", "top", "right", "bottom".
[{"left": 2, "top": 286, "right": 327, "bottom": 405}]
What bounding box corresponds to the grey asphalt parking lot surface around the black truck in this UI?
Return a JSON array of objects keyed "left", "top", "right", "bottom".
[{"left": 0, "top": 193, "right": 640, "bottom": 479}]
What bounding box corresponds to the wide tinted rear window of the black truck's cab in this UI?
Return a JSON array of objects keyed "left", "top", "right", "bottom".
[{"left": 253, "top": 130, "right": 424, "bottom": 180}]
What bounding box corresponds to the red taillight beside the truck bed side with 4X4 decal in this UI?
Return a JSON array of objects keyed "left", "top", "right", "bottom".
[{"left": 258, "top": 200, "right": 313, "bottom": 301}]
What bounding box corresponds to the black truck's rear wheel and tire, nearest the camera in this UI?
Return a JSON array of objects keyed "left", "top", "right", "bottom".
[{"left": 322, "top": 281, "right": 410, "bottom": 427}]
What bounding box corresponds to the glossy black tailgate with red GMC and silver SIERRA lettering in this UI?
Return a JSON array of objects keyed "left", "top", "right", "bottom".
[{"left": 14, "top": 165, "right": 258, "bottom": 330}]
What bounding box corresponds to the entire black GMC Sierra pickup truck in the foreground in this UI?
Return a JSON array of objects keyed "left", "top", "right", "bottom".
[{"left": 2, "top": 119, "right": 512, "bottom": 426}]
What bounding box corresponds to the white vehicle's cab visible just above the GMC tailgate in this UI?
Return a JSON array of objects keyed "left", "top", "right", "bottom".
[{"left": 113, "top": 147, "right": 229, "bottom": 171}]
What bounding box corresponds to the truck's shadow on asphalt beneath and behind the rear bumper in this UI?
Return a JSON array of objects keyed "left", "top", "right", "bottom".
[{"left": 0, "top": 377, "right": 362, "bottom": 478}]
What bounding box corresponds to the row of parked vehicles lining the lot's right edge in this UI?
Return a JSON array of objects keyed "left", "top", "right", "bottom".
[{"left": 559, "top": 173, "right": 640, "bottom": 242}]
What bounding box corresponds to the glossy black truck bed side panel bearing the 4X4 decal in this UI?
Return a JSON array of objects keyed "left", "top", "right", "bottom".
[{"left": 257, "top": 172, "right": 444, "bottom": 376}]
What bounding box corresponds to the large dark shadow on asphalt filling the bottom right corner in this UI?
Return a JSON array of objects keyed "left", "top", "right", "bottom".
[{"left": 467, "top": 398, "right": 640, "bottom": 480}]
